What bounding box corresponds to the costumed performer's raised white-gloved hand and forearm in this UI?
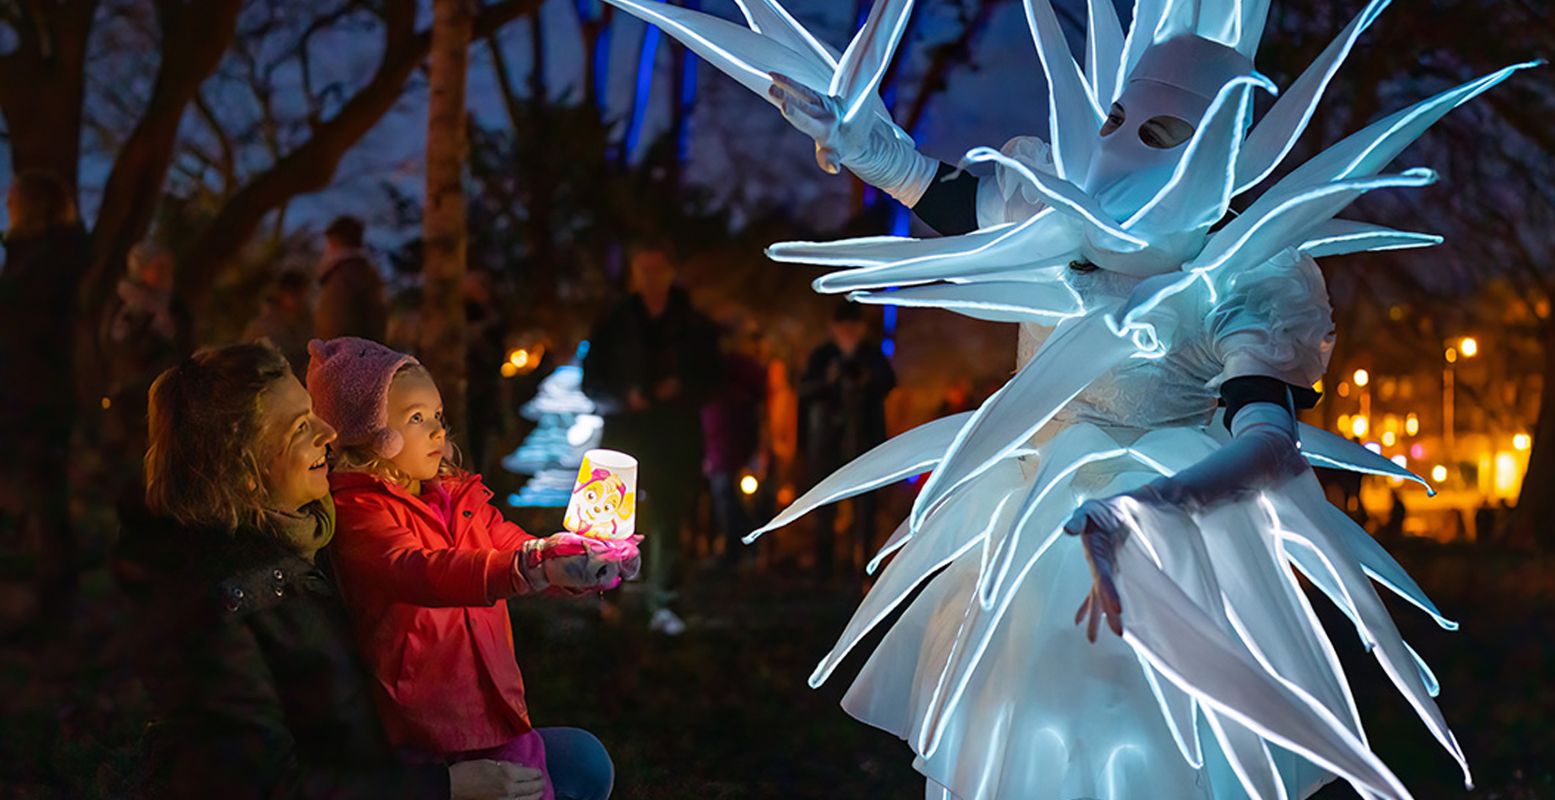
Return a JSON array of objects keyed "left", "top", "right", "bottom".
[{"left": 767, "top": 72, "right": 939, "bottom": 209}]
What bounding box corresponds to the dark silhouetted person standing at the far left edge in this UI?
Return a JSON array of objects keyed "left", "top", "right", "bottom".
[{"left": 0, "top": 170, "right": 92, "bottom": 629}]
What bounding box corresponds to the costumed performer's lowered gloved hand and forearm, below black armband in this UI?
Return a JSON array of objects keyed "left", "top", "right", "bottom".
[{"left": 1064, "top": 403, "right": 1306, "bottom": 641}]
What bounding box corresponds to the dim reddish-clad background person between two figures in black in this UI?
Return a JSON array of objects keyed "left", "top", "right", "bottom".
[{"left": 701, "top": 326, "right": 767, "bottom": 567}]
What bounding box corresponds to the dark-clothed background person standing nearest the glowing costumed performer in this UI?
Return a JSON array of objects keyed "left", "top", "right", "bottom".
[{"left": 799, "top": 300, "right": 896, "bottom": 579}]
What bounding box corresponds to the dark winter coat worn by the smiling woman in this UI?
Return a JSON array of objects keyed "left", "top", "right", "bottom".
[{"left": 115, "top": 509, "right": 449, "bottom": 800}]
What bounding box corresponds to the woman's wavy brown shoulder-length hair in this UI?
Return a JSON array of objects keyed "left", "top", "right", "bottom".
[{"left": 146, "top": 341, "right": 292, "bottom": 529}]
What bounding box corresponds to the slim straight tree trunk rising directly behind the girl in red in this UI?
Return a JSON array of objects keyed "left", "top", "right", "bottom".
[{"left": 421, "top": 0, "right": 474, "bottom": 430}]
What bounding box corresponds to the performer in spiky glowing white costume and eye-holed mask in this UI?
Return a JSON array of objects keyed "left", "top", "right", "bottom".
[{"left": 608, "top": 0, "right": 1532, "bottom": 800}]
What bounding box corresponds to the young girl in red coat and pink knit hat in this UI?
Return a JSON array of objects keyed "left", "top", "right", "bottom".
[{"left": 308, "top": 336, "right": 638, "bottom": 800}]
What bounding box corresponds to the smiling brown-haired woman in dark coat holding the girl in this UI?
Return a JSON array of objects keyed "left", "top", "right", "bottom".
[{"left": 117, "top": 342, "right": 541, "bottom": 800}]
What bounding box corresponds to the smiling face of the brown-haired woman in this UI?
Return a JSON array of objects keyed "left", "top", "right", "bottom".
[{"left": 257, "top": 375, "right": 334, "bottom": 511}]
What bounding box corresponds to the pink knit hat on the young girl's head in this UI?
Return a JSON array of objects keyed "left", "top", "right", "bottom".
[{"left": 308, "top": 336, "right": 420, "bottom": 458}]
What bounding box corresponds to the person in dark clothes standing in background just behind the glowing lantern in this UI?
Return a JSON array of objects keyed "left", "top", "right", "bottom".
[{"left": 583, "top": 244, "right": 718, "bottom": 633}]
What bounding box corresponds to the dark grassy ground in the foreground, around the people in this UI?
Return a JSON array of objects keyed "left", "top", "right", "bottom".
[{"left": 0, "top": 532, "right": 1555, "bottom": 800}]
